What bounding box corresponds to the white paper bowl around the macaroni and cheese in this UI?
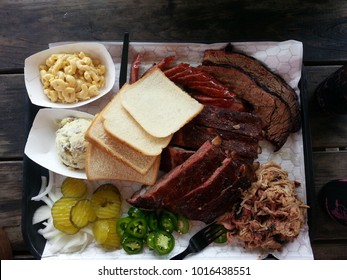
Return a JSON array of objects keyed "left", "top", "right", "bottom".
[{"left": 24, "top": 43, "right": 116, "bottom": 108}]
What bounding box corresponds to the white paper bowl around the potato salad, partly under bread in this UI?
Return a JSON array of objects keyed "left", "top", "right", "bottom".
[{"left": 24, "top": 108, "right": 93, "bottom": 179}]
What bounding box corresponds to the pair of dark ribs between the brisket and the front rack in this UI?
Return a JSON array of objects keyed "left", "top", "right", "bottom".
[{"left": 169, "top": 106, "right": 262, "bottom": 162}]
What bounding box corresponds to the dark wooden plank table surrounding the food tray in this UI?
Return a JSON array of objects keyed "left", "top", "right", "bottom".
[{"left": 0, "top": 0, "right": 347, "bottom": 259}]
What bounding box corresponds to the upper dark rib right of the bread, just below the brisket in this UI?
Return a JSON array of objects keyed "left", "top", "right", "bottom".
[{"left": 192, "top": 106, "right": 262, "bottom": 140}]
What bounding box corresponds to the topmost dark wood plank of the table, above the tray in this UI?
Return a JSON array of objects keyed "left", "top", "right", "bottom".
[{"left": 0, "top": 0, "right": 347, "bottom": 71}]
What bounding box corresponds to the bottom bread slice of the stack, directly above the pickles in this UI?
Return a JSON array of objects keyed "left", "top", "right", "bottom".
[{"left": 86, "top": 143, "right": 160, "bottom": 185}]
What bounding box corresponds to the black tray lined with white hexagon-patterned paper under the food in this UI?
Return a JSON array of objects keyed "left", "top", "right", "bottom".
[{"left": 23, "top": 40, "right": 313, "bottom": 259}]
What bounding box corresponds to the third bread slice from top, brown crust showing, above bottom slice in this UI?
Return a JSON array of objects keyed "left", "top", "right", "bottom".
[{"left": 85, "top": 112, "right": 158, "bottom": 174}]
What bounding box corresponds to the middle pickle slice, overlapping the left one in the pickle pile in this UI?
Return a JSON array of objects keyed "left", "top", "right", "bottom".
[{"left": 70, "top": 199, "right": 96, "bottom": 228}]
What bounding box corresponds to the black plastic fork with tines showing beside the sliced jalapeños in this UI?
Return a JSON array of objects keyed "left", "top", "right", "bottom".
[{"left": 170, "top": 222, "right": 226, "bottom": 260}]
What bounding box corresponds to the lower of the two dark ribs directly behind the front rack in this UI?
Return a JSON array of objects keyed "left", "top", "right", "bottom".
[{"left": 170, "top": 123, "right": 260, "bottom": 162}]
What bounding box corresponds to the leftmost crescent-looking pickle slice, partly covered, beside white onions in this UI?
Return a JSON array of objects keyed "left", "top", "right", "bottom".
[{"left": 51, "top": 197, "right": 79, "bottom": 234}]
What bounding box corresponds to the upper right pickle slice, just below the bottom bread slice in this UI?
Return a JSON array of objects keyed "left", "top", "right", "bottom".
[{"left": 91, "top": 184, "right": 121, "bottom": 219}]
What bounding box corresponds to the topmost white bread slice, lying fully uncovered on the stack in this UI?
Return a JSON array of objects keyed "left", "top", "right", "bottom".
[{"left": 121, "top": 67, "right": 203, "bottom": 137}]
